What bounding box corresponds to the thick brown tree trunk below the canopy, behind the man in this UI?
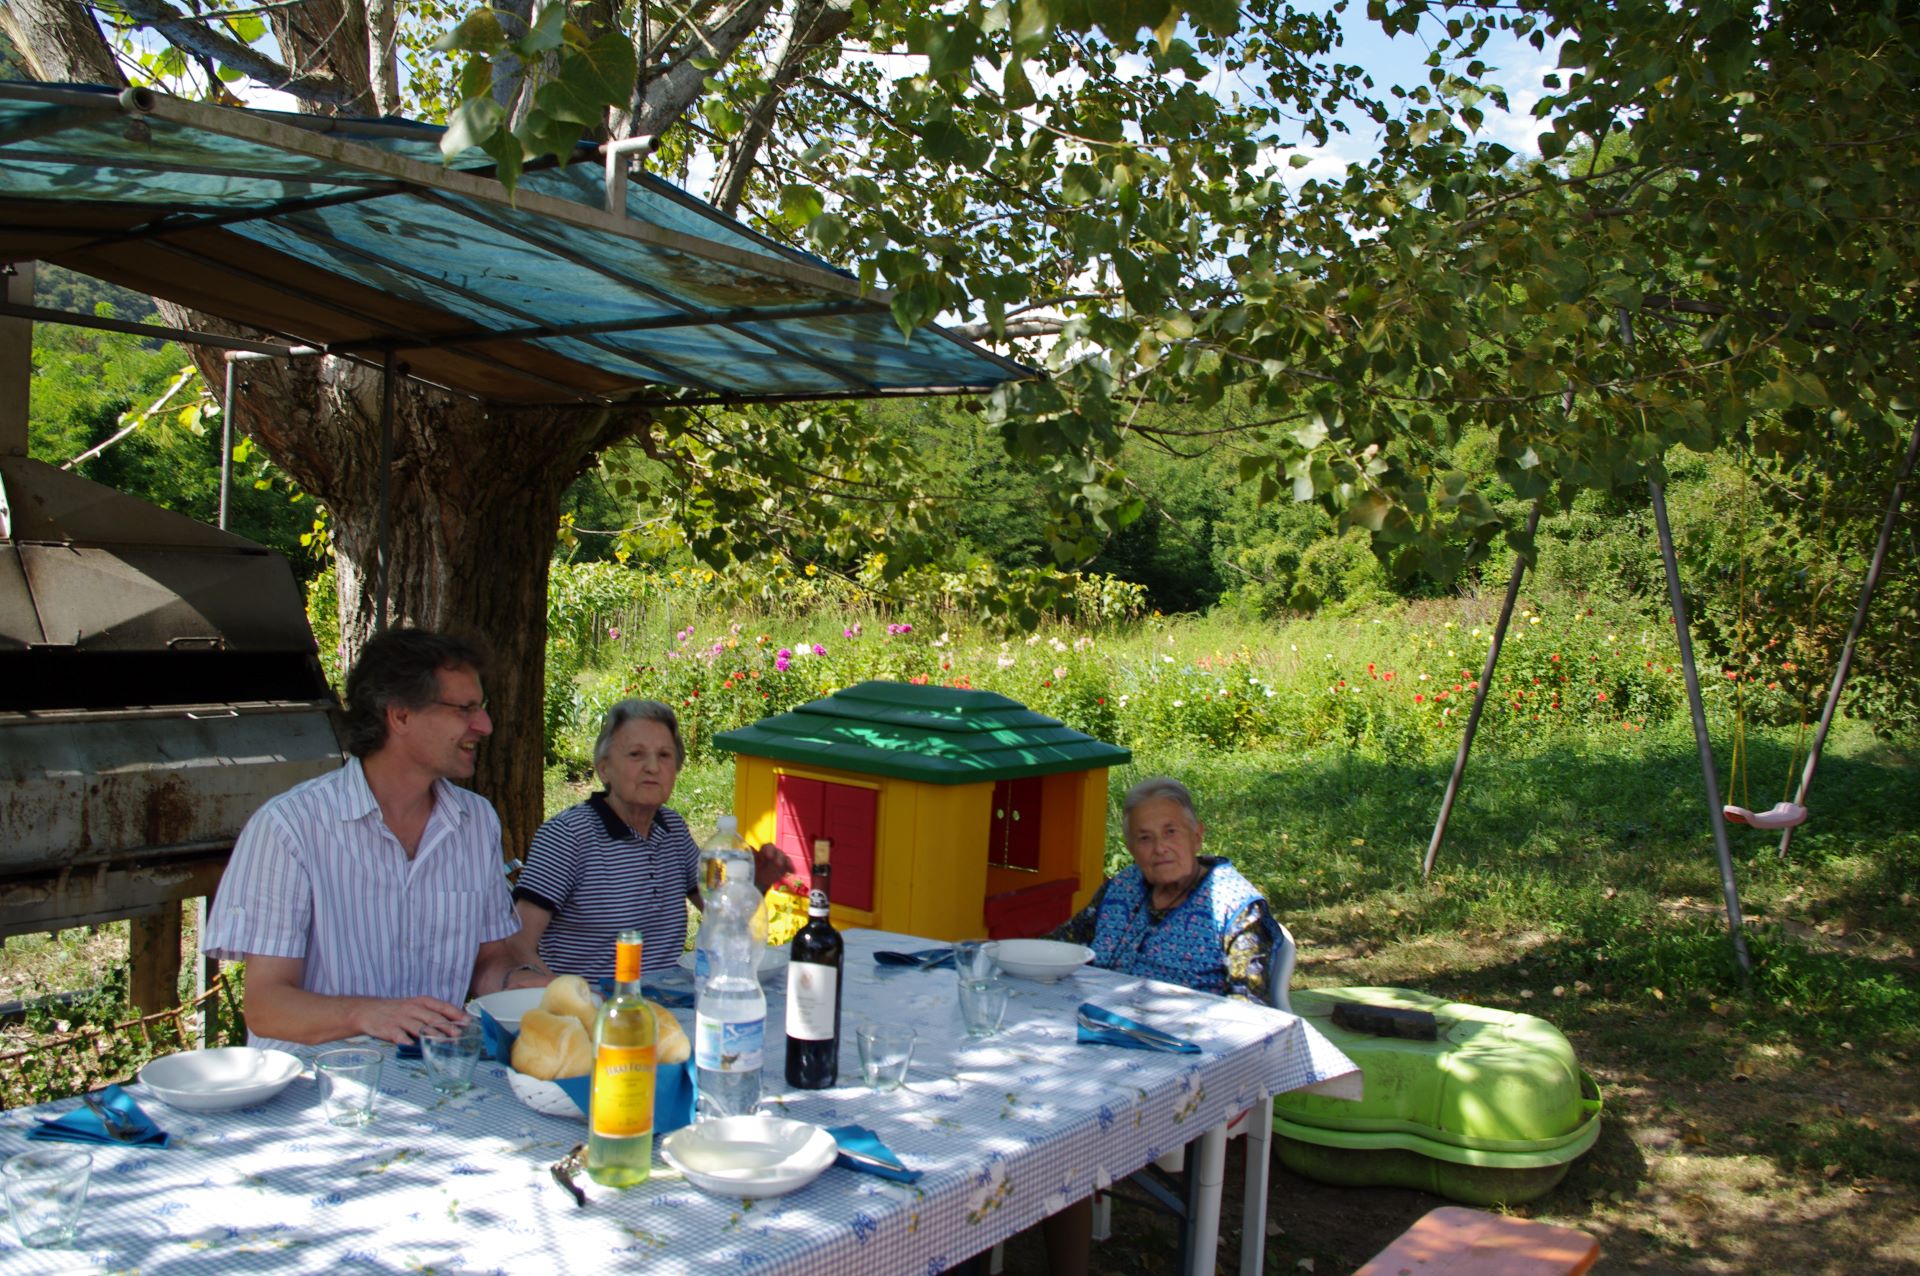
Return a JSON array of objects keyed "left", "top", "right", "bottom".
[{"left": 205, "top": 343, "right": 647, "bottom": 856}]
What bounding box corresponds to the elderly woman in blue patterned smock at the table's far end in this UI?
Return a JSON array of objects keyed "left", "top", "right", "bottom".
[{"left": 1054, "top": 779, "right": 1279, "bottom": 1002}]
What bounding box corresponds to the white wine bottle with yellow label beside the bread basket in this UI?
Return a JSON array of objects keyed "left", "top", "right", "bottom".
[{"left": 588, "top": 931, "right": 659, "bottom": 1188}]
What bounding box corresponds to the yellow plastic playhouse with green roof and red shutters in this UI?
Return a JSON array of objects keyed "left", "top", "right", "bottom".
[{"left": 714, "top": 681, "right": 1133, "bottom": 940}]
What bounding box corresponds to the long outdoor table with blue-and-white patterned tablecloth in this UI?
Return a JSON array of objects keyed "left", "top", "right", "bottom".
[{"left": 0, "top": 931, "right": 1359, "bottom": 1276}]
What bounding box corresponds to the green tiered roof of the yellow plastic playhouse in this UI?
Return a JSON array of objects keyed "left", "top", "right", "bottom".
[{"left": 714, "top": 681, "right": 1133, "bottom": 785}]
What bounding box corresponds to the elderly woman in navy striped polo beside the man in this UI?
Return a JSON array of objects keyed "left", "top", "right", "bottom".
[{"left": 513, "top": 700, "right": 787, "bottom": 979}]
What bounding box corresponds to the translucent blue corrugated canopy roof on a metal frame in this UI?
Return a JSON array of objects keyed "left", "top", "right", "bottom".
[{"left": 0, "top": 83, "right": 1033, "bottom": 403}]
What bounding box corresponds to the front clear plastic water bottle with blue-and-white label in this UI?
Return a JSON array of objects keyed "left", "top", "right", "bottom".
[{"left": 693, "top": 850, "right": 766, "bottom": 1121}]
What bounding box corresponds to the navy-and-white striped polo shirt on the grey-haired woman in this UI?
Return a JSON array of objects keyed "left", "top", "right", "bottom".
[{"left": 513, "top": 792, "right": 701, "bottom": 979}]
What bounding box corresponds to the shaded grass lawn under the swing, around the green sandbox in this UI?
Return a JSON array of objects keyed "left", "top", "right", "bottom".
[{"left": 1008, "top": 731, "right": 1920, "bottom": 1272}]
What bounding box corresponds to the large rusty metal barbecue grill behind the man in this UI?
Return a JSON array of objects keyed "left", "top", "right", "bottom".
[{"left": 0, "top": 453, "right": 342, "bottom": 1009}]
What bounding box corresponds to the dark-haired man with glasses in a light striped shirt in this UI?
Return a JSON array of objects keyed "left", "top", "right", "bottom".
[{"left": 204, "top": 629, "right": 549, "bottom": 1048}]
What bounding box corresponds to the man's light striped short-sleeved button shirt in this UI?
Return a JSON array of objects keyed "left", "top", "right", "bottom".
[{"left": 204, "top": 758, "right": 520, "bottom": 1050}]
